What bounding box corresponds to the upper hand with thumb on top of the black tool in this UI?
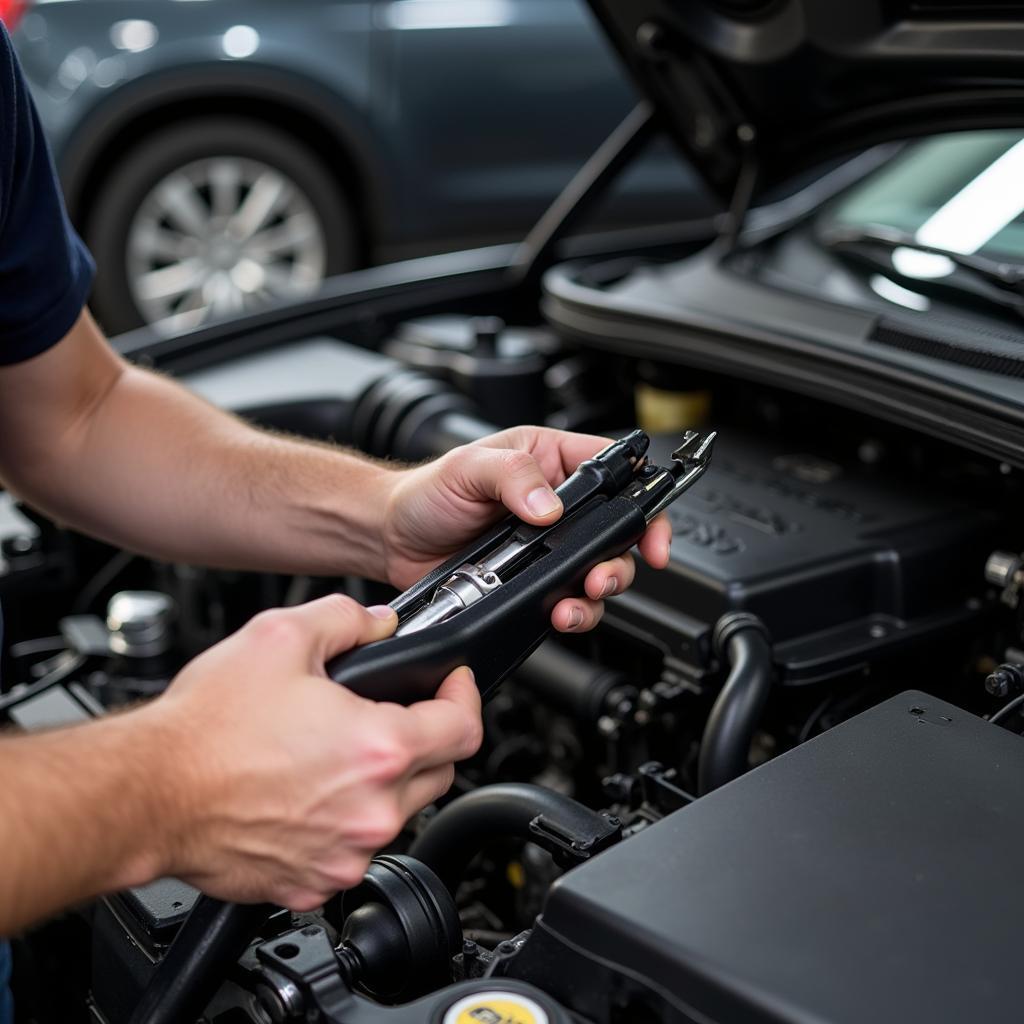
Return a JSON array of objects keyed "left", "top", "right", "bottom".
[{"left": 383, "top": 427, "right": 672, "bottom": 633}]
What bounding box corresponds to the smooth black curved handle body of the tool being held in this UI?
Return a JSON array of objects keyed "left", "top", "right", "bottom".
[{"left": 327, "top": 497, "right": 647, "bottom": 705}]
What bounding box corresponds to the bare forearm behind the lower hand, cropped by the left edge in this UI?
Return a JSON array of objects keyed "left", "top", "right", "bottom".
[{"left": 0, "top": 711, "right": 177, "bottom": 936}]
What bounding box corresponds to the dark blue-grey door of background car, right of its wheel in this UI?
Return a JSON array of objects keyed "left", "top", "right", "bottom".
[{"left": 373, "top": 0, "right": 647, "bottom": 255}]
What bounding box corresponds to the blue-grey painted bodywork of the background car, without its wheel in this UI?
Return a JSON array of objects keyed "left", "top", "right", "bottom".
[{"left": 15, "top": 0, "right": 707, "bottom": 259}]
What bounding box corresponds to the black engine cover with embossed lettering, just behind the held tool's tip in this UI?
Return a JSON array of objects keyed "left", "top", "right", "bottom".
[{"left": 608, "top": 431, "right": 995, "bottom": 684}]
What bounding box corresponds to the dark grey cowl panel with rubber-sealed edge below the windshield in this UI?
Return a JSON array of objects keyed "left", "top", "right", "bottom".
[{"left": 543, "top": 249, "right": 1024, "bottom": 467}]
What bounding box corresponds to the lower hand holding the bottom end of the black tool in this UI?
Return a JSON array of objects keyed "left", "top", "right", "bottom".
[{"left": 144, "top": 595, "right": 482, "bottom": 910}]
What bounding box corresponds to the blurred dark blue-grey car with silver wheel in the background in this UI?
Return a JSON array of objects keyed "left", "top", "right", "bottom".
[{"left": 0, "top": 0, "right": 706, "bottom": 332}]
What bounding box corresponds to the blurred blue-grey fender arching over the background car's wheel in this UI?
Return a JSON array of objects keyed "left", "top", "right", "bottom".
[{"left": 15, "top": 0, "right": 383, "bottom": 226}]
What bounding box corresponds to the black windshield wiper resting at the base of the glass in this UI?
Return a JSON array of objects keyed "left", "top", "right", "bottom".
[{"left": 818, "top": 224, "right": 1024, "bottom": 313}]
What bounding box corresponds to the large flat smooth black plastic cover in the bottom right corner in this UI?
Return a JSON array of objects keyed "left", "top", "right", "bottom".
[{"left": 515, "top": 691, "right": 1024, "bottom": 1024}]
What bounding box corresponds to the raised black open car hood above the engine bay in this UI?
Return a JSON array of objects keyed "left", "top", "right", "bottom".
[{"left": 589, "top": 0, "right": 1024, "bottom": 204}]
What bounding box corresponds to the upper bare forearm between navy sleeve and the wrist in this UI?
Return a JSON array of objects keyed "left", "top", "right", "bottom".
[{"left": 4, "top": 352, "right": 403, "bottom": 578}]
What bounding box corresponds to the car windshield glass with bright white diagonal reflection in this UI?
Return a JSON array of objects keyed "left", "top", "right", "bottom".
[{"left": 821, "top": 130, "right": 1024, "bottom": 264}]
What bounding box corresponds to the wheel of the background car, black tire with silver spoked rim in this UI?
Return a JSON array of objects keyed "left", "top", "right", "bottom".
[{"left": 84, "top": 117, "right": 360, "bottom": 334}]
